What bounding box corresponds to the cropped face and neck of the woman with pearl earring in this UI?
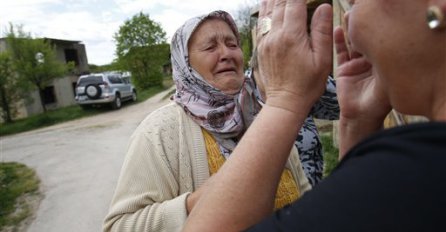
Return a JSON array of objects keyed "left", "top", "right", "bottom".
[{"left": 347, "top": 0, "right": 446, "bottom": 113}]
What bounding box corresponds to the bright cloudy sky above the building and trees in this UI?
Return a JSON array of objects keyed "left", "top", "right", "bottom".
[{"left": 0, "top": 0, "right": 258, "bottom": 65}]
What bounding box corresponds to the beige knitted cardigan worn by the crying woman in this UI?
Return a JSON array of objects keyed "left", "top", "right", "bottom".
[{"left": 103, "top": 103, "right": 310, "bottom": 232}]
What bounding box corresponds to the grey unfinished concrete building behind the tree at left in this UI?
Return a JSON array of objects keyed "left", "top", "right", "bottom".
[{"left": 0, "top": 38, "right": 89, "bottom": 118}]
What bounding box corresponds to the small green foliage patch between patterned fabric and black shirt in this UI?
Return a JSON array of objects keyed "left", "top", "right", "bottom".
[{"left": 321, "top": 132, "right": 339, "bottom": 177}]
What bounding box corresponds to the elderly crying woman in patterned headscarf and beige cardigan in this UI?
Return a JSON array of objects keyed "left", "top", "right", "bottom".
[{"left": 104, "top": 11, "right": 310, "bottom": 232}]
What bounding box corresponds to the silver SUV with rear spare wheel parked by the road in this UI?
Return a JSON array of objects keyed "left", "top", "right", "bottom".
[{"left": 75, "top": 72, "right": 136, "bottom": 109}]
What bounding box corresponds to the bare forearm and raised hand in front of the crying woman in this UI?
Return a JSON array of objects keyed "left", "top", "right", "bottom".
[{"left": 184, "top": 0, "right": 332, "bottom": 231}]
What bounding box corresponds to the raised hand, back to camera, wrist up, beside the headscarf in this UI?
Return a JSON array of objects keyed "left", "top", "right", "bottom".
[{"left": 257, "top": 0, "right": 333, "bottom": 116}]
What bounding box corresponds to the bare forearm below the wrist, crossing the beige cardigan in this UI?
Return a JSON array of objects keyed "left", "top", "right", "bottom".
[{"left": 185, "top": 105, "right": 306, "bottom": 231}]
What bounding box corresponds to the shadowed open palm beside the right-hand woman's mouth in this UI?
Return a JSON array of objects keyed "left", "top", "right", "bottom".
[{"left": 334, "top": 27, "right": 391, "bottom": 158}]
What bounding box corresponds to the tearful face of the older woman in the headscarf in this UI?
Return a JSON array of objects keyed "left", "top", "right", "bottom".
[{"left": 188, "top": 19, "right": 244, "bottom": 94}]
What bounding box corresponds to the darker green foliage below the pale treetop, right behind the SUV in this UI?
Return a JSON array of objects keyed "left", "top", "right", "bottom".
[{"left": 125, "top": 44, "right": 170, "bottom": 89}]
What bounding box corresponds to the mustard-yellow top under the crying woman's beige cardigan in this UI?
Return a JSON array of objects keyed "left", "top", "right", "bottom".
[{"left": 201, "top": 129, "right": 300, "bottom": 210}]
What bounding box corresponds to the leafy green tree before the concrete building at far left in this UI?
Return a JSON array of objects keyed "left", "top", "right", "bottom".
[{"left": 6, "top": 25, "right": 69, "bottom": 112}]
